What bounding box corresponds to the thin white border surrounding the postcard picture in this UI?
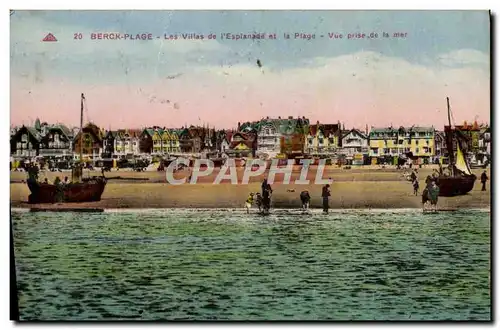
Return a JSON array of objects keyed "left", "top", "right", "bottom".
[{"left": 0, "top": 0, "right": 500, "bottom": 329}]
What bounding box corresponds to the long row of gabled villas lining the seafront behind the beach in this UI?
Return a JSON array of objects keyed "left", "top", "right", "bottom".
[{"left": 11, "top": 117, "right": 491, "bottom": 164}]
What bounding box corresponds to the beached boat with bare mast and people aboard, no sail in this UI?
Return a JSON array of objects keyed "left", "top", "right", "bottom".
[{"left": 27, "top": 93, "right": 107, "bottom": 204}]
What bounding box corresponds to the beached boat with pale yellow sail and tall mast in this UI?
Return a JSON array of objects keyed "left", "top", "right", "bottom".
[{"left": 437, "top": 97, "right": 477, "bottom": 197}]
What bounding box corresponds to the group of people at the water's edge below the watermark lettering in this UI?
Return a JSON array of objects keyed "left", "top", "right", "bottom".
[{"left": 245, "top": 179, "right": 331, "bottom": 214}]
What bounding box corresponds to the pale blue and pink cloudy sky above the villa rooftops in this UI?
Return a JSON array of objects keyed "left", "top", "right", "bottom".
[{"left": 10, "top": 11, "right": 490, "bottom": 129}]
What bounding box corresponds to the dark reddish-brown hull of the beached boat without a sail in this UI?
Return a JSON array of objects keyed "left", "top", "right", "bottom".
[{"left": 28, "top": 178, "right": 106, "bottom": 204}]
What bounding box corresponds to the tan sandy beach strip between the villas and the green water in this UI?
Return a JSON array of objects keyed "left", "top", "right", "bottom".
[{"left": 10, "top": 168, "right": 490, "bottom": 210}]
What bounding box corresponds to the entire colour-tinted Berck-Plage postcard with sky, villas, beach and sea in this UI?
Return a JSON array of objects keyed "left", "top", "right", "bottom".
[{"left": 10, "top": 10, "right": 492, "bottom": 321}]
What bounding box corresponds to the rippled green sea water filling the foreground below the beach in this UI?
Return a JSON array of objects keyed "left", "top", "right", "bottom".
[{"left": 12, "top": 210, "right": 491, "bottom": 320}]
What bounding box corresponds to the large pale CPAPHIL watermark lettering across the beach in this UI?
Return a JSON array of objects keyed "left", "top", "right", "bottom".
[{"left": 165, "top": 158, "right": 333, "bottom": 185}]
